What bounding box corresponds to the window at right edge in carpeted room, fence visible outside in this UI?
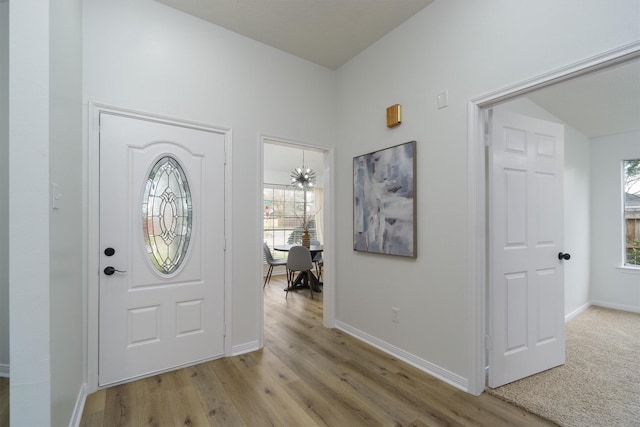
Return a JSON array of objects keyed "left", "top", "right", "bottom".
[{"left": 623, "top": 159, "right": 640, "bottom": 266}]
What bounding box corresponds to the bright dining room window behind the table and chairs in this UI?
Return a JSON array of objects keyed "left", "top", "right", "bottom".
[{"left": 263, "top": 184, "right": 317, "bottom": 258}]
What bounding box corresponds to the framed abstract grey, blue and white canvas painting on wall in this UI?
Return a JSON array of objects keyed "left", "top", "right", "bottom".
[{"left": 353, "top": 141, "right": 417, "bottom": 258}]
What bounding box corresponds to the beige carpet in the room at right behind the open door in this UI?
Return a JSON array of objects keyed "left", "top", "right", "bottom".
[{"left": 487, "top": 306, "right": 640, "bottom": 427}]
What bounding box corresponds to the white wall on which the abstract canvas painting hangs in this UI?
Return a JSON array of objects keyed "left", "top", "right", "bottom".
[{"left": 335, "top": 0, "right": 640, "bottom": 388}]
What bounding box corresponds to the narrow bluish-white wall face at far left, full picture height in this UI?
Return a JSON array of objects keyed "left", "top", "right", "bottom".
[{"left": 9, "top": 0, "right": 51, "bottom": 427}]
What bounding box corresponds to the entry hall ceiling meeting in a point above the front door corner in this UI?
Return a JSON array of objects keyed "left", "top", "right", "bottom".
[{"left": 156, "top": 0, "right": 433, "bottom": 70}]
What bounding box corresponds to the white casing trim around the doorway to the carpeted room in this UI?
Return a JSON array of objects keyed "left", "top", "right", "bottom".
[{"left": 467, "top": 41, "right": 640, "bottom": 395}]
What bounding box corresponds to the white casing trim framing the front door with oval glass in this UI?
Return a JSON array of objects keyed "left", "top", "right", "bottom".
[{"left": 83, "top": 101, "right": 233, "bottom": 393}]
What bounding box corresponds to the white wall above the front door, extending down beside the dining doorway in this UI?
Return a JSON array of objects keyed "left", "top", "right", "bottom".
[{"left": 84, "top": 0, "right": 336, "bottom": 348}]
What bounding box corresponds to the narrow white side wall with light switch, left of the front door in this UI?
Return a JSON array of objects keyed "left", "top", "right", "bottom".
[{"left": 49, "top": 0, "right": 85, "bottom": 426}]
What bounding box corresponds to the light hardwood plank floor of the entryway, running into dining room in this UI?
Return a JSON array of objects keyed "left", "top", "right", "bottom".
[{"left": 81, "top": 276, "right": 552, "bottom": 427}]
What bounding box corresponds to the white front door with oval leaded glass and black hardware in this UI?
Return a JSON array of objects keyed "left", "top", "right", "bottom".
[{"left": 98, "top": 112, "right": 225, "bottom": 386}]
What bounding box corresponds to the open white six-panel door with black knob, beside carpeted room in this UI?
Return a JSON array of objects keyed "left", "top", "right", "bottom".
[{"left": 488, "top": 110, "right": 565, "bottom": 387}]
